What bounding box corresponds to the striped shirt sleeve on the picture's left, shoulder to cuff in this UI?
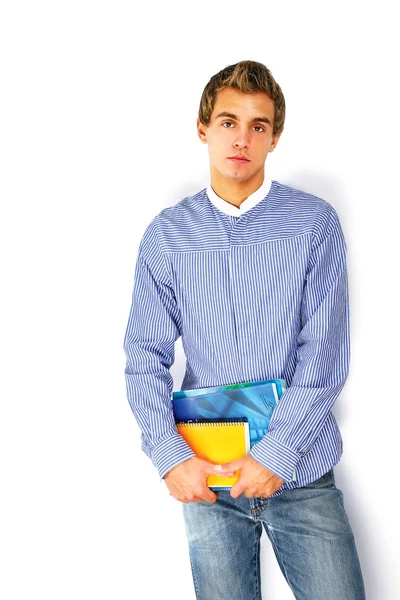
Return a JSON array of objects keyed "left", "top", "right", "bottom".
[{"left": 124, "top": 217, "right": 195, "bottom": 479}]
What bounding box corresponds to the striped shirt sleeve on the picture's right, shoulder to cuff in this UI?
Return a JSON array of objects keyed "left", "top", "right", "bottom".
[{"left": 250, "top": 203, "right": 350, "bottom": 481}]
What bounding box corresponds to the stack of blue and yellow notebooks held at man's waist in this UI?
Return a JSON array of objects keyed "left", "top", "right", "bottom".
[{"left": 172, "top": 379, "right": 286, "bottom": 490}]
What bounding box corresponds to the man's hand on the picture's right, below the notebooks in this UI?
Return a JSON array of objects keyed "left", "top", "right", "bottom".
[{"left": 213, "top": 454, "right": 285, "bottom": 498}]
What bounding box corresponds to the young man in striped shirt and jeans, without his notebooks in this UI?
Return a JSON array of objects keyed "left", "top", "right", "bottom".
[{"left": 124, "top": 61, "right": 365, "bottom": 600}]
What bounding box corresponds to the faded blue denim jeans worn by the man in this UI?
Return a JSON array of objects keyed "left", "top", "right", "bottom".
[{"left": 182, "top": 469, "right": 365, "bottom": 600}]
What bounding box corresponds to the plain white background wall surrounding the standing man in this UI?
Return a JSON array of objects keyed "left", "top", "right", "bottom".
[{"left": 0, "top": 0, "right": 400, "bottom": 600}]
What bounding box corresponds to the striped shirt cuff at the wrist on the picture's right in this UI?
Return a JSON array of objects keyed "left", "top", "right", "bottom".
[{"left": 249, "top": 433, "right": 300, "bottom": 481}]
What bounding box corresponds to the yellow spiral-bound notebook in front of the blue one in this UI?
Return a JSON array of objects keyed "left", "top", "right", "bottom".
[{"left": 176, "top": 420, "right": 250, "bottom": 490}]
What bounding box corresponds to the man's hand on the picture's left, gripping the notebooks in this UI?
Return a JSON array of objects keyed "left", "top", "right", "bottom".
[{"left": 164, "top": 456, "right": 232, "bottom": 504}]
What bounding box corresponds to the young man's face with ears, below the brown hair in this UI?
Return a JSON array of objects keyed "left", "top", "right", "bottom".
[{"left": 197, "top": 87, "right": 280, "bottom": 182}]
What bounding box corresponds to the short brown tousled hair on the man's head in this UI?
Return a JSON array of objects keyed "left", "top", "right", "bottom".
[{"left": 198, "top": 60, "right": 286, "bottom": 135}]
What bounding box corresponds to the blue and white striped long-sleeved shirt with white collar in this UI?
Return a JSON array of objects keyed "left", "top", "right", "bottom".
[{"left": 124, "top": 179, "right": 349, "bottom": 495}]
